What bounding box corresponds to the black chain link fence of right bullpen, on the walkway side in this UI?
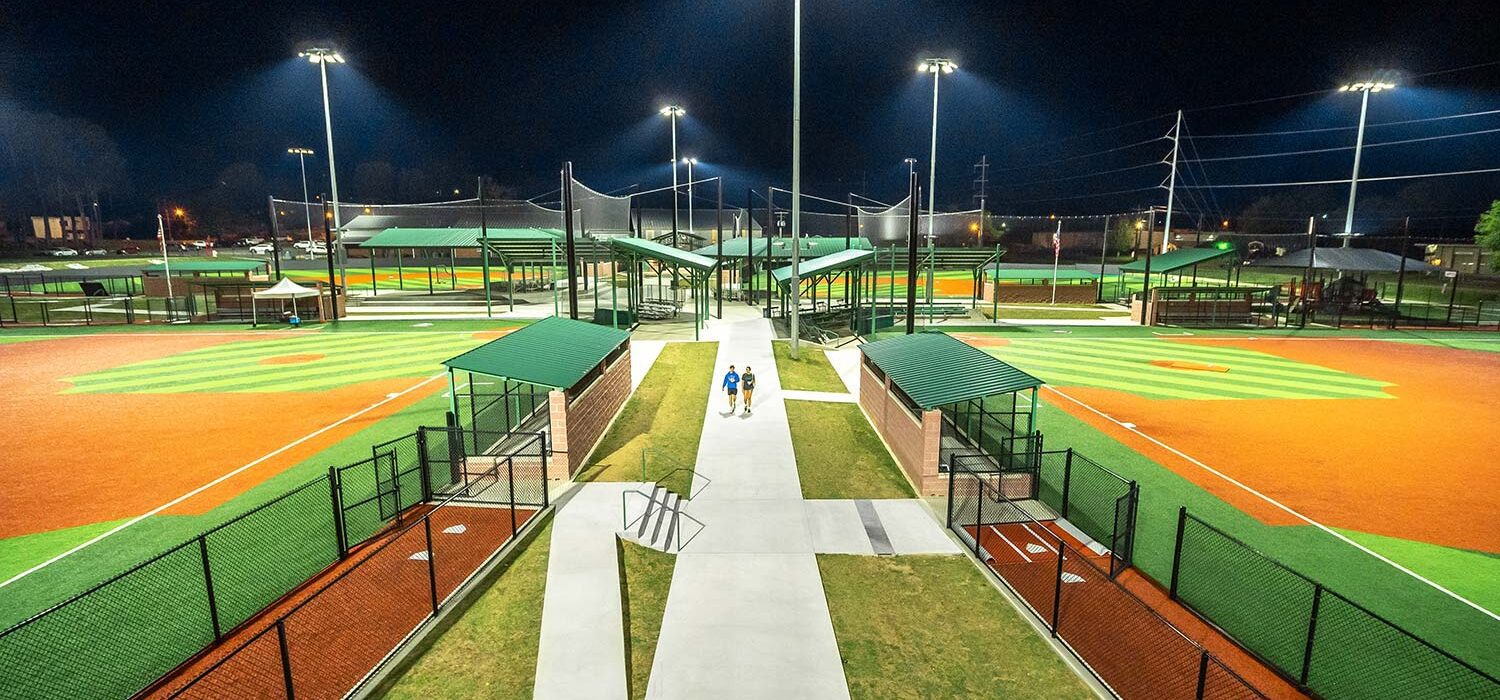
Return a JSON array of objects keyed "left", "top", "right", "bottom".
[{"left": 948, "top": 462, "right": 1265, "bottom": 699}]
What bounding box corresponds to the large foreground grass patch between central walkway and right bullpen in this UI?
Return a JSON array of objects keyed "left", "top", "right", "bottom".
[{"left": 818, "top": 555, "right": 1095, "bottom": 700}]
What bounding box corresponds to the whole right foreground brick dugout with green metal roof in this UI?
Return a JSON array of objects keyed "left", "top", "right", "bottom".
[{"left": 860, "top": 331, "right": 1043, "bottom": 495}]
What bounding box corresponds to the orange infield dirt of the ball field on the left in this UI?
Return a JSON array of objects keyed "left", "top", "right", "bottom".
[{"left": 0, "top": 333, "right": 443, "bottom": 538}]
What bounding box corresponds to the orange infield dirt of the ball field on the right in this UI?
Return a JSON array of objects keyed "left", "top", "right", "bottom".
[{"left": 1043, "top": 337, "right": 1500, "bottom": 552}]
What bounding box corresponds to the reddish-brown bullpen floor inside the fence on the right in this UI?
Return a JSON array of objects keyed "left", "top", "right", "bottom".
[{"left": 969, "top": 523, "right": 1307, "bottom": 700}]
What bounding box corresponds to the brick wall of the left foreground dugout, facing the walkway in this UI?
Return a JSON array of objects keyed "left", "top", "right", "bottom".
[{"left": 548, "top": 346, "right": 630, "bottom": 480}]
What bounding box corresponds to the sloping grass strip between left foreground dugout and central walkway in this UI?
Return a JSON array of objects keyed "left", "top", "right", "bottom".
[{"left": 579, "top": 343, "right": 719, "bottom": 496}]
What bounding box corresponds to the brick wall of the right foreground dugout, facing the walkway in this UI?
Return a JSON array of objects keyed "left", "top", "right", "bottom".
[{"left": 860, "top": 361, "right": 948, "bottom": 496}]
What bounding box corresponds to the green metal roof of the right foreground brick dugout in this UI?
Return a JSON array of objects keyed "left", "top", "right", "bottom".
[{"left": 860, "top": 331, "right": 1043, "bottom": 411}]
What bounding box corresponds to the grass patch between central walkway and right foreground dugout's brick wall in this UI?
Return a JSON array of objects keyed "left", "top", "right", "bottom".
[{"left": 786, "top": 400, "right": 917, "bottom": 498}]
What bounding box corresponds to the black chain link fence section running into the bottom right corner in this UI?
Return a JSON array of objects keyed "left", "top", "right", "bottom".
[{"left": 1170, "top": 508, "right": 1500, "bottom": 699}]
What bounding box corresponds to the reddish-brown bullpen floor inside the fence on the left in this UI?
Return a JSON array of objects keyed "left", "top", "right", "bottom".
[{"left": 141, "top": 505, "right": 536, "bottom": 699}]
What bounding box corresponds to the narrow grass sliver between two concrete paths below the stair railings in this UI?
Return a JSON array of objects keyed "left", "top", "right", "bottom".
[{"left": 617, "top": 540, "right": 677, "bottom": 699}]
